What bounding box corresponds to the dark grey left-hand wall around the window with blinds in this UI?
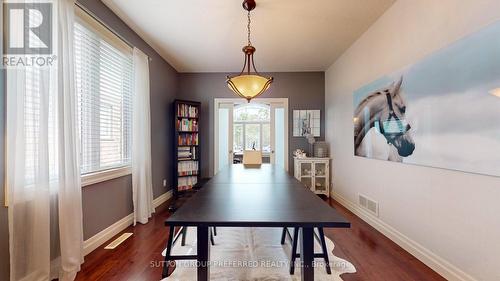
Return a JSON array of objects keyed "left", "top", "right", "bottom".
[{"left": 78, "top": 0, "right": 178, "bottom": 239}]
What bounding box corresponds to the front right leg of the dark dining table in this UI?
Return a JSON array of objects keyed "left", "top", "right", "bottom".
[{"left": 300, "top": 227, "right": 314, "bottom": 281}]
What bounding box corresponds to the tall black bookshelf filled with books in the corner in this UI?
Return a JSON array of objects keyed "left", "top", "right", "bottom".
[{"left": 173, "top": 100, "right": 201, "bottom": 199}]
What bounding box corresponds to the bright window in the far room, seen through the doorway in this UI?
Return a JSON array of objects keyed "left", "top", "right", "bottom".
[{"left": 233, "top": 103, "right": 271, "bottom": 153}]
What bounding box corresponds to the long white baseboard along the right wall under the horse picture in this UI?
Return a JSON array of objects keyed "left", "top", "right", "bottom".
[{"left": 331, "top": 192, "right": 477, "bottom": 281}]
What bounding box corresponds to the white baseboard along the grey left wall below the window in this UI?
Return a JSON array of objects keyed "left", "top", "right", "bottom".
[{"left": 83, "top": 190, "right": 172, "bottom": 256}]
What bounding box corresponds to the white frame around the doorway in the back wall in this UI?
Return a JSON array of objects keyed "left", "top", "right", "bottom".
[{"left": 214, "top": 98, "right": 290, "bottom": 174}]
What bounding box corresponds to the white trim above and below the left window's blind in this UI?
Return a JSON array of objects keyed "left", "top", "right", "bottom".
[{"left": 74, "top": 4, "right": 133, "bottom": 184}]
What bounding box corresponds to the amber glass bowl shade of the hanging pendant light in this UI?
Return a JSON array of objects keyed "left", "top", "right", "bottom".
[{"left": 227, "top": 74, "right": 273, "bottom": 101}]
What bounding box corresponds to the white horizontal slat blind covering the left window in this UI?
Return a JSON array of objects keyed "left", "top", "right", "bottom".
[{"left": 74, "top": 9, "right": 133, "bottom": 175}]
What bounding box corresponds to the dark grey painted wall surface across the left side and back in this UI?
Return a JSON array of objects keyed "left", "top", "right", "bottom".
[{"left": 0, "top": 0, "right": 325, "bottom": 280}]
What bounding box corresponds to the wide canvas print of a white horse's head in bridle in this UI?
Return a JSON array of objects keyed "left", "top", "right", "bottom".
[{"left": 353, "top": 22, "right": 500, "bottom": 176}]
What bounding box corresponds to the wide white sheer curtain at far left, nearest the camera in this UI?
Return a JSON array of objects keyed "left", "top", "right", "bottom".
[{"left": 6, "top": 0, "right": 83, "bottom": 281}]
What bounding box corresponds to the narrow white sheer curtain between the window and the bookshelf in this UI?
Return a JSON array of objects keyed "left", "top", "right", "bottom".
[{"left": 132, "top": 48, "right": 154, "bottom": 225}]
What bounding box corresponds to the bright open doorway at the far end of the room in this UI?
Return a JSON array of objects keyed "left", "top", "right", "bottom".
[{"left": 214, "top": 98, "right": 288, "bottom": 173}]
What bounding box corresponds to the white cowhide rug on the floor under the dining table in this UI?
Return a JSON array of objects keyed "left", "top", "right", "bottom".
[{"left": 162, "top": 227, "right": 356, "bottom": 281}]
